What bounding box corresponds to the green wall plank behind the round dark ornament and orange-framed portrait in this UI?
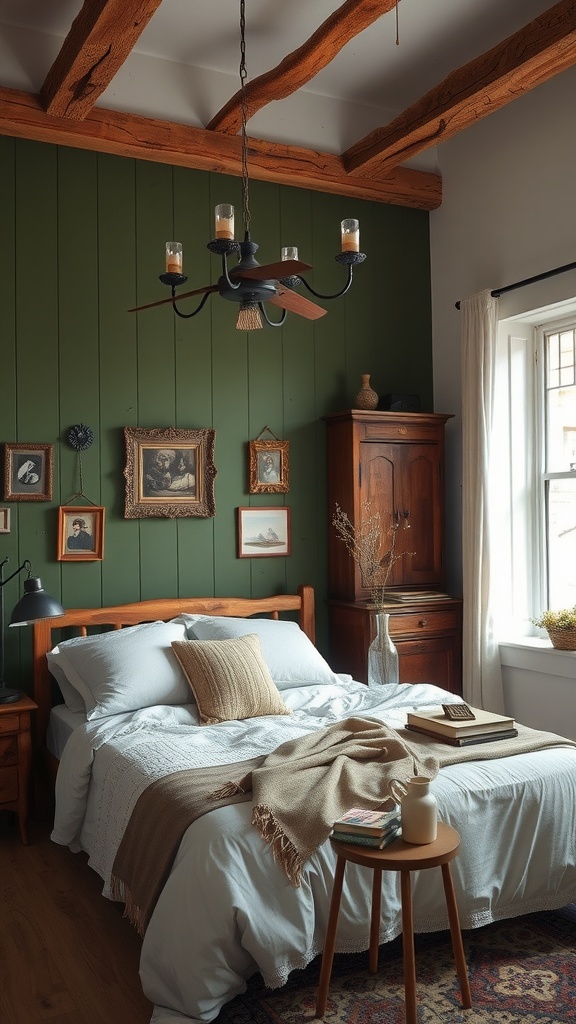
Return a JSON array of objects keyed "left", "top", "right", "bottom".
[{"left": 57, "top": 146, "right": 101, "bottom": 607}]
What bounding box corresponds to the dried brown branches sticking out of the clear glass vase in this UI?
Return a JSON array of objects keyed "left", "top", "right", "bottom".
[{"left": 332, "top": 502, "right": 413, "bottom": 608}]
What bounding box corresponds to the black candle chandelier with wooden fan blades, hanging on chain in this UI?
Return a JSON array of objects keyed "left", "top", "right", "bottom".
[{"left": 128, "top": 0, "right": 366, "bottom": 331}]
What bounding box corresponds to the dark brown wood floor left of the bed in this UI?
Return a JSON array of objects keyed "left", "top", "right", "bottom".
[{"left": 0, "top": 811, "right": 152, "bottom": 1024}]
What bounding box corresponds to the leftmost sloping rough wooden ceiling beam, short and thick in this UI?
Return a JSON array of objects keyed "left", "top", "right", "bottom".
[{"left": 40, "top": 0, "right": 162, "bottom": 121}]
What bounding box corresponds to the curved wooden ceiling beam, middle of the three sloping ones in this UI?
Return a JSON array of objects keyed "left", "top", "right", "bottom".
[{"left": 206, "top": 0, "right": 397, "bottom": 135}]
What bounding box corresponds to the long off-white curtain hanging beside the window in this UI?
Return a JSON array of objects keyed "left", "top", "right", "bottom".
[{"left": 460, "top": 291, "right": 504, "bottom": 714}]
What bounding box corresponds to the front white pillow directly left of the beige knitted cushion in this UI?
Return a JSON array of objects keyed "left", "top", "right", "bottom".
[{"left": 46, "top": 620, "right": 191, "bottom": 719}]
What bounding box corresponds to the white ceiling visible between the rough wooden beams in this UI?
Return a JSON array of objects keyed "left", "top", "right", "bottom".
[{"left": 0, "top": 0, "right": 551, "bottom": 168}]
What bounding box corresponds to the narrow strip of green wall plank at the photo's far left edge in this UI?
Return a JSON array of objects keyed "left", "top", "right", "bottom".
[{"left": 0, "top": 137, "right": 19, "bottom": 680}]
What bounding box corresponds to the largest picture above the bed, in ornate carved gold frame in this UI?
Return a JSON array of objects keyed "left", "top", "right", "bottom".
[{"left": 124, "top": 427, "right": 216, "bottom": 519}]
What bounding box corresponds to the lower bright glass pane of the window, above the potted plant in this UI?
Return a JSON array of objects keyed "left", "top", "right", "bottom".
[{"left": 547, "top": 474, "right": 576, "bottom": 608}]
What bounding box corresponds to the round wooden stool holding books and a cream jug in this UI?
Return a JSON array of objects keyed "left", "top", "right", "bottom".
[{"left": 316, "top": 821, "right": 471, "bottom": 1024}]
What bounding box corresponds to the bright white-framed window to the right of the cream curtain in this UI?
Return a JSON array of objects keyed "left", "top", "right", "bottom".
[{"left": 490, "top": 303, "right": 576, "bottom": 640}]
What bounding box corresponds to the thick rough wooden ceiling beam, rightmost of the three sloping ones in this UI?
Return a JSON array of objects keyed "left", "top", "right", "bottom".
[{"left": 342, "top": 0, "right": 576, "bottom": 176}]
